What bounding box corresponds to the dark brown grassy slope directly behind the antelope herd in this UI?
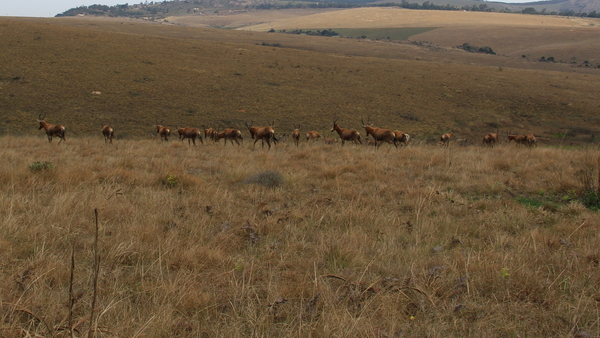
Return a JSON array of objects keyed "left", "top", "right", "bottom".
[{"left": 0, "top": 19, "right": 600, "bottom": 143}]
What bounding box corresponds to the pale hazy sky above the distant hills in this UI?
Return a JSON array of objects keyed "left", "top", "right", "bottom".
[{"left": 0, "top": 0, "right": 531, "bottom": 17}]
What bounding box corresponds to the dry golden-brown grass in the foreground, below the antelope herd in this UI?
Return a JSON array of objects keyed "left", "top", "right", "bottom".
[{"left": 0, "top": 135, "right": 600, "bottom": 337}]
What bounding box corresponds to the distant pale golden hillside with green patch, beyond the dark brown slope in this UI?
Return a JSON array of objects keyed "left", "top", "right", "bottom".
[{"left": 168, "top": 8, "right": 600, "bottom": 64}]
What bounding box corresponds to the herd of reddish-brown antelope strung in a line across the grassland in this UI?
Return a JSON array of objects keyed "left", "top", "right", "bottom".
[{"left": 37, "top": 115, "right": 537, "bottom": 149}]
